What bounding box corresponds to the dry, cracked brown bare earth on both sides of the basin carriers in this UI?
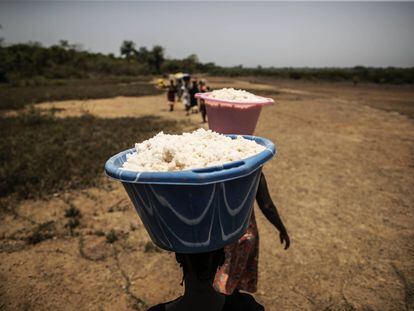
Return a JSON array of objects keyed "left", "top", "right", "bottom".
[{"left": 0, "top": 78, "right": 414, "bottom": 310}]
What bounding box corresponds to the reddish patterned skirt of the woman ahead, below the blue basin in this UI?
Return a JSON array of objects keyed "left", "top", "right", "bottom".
[{"left": 214, "top": 211, "right": 259, "bottom": 295}]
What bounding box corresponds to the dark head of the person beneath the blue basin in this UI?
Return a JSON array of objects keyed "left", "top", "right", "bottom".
[{"left": 175, "top": 248, "right": 224, "bottom": 281}]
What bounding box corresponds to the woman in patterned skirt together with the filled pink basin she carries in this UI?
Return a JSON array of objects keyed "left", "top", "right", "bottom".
[{"left": 197, "top": 88, "right": 290, "bottom": 295}]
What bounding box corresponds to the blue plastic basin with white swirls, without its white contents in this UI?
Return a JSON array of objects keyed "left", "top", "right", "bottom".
[{"left": 105, "top": 135, "right": 276, "bottom": 253}]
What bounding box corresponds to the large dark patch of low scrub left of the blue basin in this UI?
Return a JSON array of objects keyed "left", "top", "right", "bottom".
[{"left": 0, "top": 109, "right": 183, "bottom": 199}]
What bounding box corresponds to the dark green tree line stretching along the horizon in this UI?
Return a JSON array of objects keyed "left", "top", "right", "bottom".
[{"left": 0, "top": 40, "right": 414, "bottom": 84}]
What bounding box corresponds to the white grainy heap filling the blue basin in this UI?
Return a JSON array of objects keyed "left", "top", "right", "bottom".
[{"left": 123, "top": 129, "right": 265, "bottom": 172}]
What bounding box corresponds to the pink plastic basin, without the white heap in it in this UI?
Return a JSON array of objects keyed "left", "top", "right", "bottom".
[{"left": 196, "top": 92, "right": 274, "bottom": 135}]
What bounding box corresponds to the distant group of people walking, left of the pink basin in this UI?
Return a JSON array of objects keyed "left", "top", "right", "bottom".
[{"left": 167, "top": 79, "right": 210, "bottom": 123}]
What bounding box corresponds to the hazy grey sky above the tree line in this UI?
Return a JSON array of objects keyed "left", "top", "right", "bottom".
[{"left": 0, "top": 1, "right": 414, "bottom": 67}]
